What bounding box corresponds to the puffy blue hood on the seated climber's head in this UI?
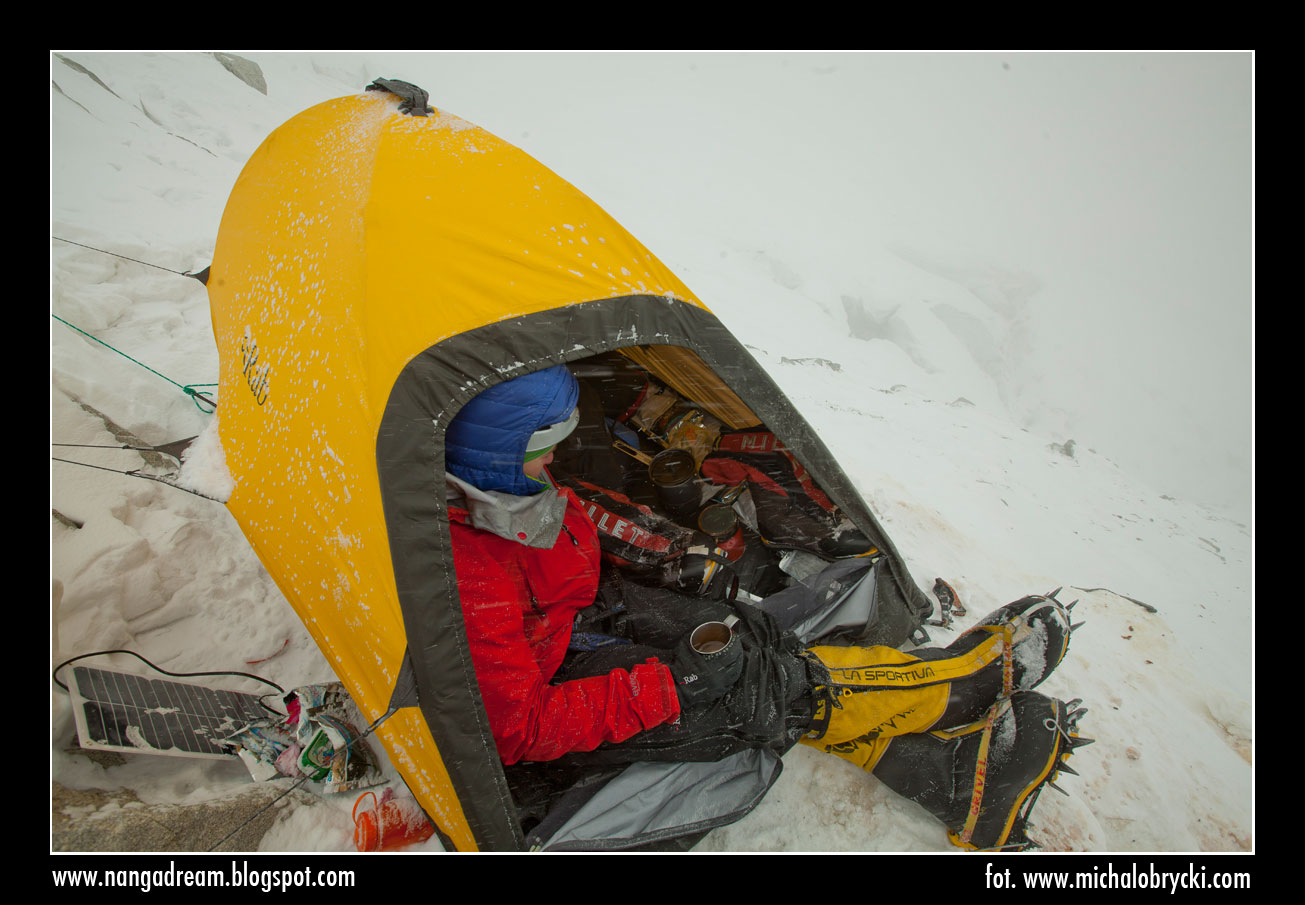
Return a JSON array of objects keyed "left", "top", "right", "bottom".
[{"left": 444, "top": 364, "right": 579, "bottom": 496}]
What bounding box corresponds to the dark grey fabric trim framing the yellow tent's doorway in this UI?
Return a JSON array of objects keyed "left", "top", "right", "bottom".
[{"left": 376, "top": 295, "right": 930, "bottom": 851}]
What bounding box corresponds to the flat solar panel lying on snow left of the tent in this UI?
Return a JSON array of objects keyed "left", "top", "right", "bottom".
[{"left": 69, "top": 666, "right": 269, "bottom": 757}]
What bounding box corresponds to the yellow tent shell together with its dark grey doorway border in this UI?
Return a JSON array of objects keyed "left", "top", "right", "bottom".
[{"left": 206, "top": 82, "right": 929, "bottom": 850}]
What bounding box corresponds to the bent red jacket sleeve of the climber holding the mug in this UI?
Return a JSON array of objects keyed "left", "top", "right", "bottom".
[{"left": 455, "top": 530, "right": 680, "bottom": 764}]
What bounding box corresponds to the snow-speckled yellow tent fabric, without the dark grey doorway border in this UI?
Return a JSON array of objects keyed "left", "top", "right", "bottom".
[{"left": 206, "top": 91, "right": 699, "bottom": 849}]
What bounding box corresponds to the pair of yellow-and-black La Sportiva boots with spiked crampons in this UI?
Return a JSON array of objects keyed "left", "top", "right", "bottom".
[{"left": 803, "top": 592, "right": 1092, "bottom": 849}]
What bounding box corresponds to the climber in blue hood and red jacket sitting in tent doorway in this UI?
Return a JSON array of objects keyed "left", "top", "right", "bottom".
[{"left": 445, "top": 366, "right": 1086, "bottom": 849}]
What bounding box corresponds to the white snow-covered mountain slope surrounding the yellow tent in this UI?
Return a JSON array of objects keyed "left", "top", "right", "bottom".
[{"left": 51, "top": 51, "right": 1254, "bottom": 851}]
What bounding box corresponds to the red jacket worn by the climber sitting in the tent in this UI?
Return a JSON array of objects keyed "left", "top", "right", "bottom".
[{"left": 449, "top": 487, "right": 680, "bottom": 764}]
